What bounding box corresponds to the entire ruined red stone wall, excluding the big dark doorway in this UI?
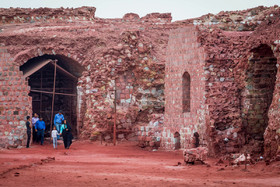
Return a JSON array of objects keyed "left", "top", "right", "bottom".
[{"left": 0, "top": 6, "right": 280, "bottom": 160}]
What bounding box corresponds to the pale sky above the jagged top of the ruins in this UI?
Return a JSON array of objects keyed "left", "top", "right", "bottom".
[{"left": 0, "top": 0, "right": 280, "bottom": 21}]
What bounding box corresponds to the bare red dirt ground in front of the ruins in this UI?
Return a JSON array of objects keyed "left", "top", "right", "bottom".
[{"left": 0, "top": 141, "right": 280, "bottom": 187}]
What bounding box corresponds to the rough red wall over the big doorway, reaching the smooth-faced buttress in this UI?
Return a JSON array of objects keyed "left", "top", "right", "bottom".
[{"left": 0, "top": 8, "right": 175, "bottom": 148}]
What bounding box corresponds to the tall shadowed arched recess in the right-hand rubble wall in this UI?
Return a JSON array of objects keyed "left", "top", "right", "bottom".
[{"left": 242, "top": 45, "right": 277, "bottom": 150}]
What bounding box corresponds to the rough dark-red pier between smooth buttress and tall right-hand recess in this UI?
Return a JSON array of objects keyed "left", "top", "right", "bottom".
[{"left": 199, "top": 29, "right": 250, "bottom": 155}]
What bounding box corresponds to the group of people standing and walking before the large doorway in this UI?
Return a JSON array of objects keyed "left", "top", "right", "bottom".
[{"left": 26, "top": 110, "right": 73, "bottom": 149}]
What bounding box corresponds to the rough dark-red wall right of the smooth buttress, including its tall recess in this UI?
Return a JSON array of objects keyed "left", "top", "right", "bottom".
[{"left": 199, "top": 10, "right": 279, "bottom": 158}]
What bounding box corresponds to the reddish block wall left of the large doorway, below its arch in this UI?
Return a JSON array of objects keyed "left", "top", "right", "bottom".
[{"left": 0, "top": 46, "right": 31, "bottom": 148}]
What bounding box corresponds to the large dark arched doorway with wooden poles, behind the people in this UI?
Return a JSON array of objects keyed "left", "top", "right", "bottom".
[{"left": 20, "top": 55, "right": 84, "bottom": 135}]
